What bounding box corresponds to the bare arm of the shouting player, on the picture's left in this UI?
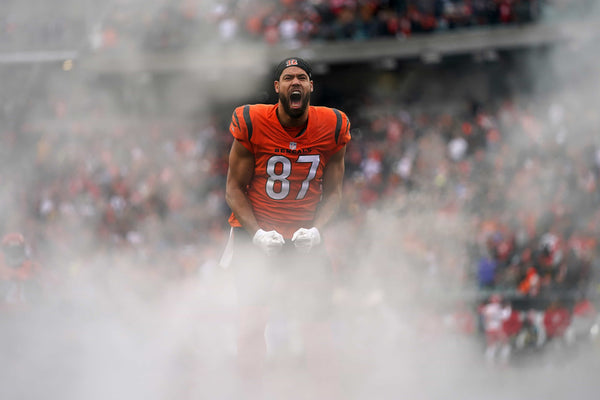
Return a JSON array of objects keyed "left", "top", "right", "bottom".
[{"left": 225, "top": 139, "right": 260, "bottom": 236}]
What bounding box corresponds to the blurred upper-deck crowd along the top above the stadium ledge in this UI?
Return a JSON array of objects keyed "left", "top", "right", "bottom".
[{"left": 0, "top": 0, "right": 593, "bottom": 51}]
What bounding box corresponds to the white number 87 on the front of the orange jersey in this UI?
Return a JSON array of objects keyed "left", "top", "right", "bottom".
[{"left": 266, "top": 154, "right": 321, "bottom": 200}]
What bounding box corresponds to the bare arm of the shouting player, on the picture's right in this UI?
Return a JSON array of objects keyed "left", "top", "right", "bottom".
[{"left": 313, "top": 146, "right": 346, "bottom": 230}]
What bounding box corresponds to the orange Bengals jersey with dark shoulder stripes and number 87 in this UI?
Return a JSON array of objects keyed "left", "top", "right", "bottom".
[{"left": 229, "top": 104, "right": 350, "bottom": 239}]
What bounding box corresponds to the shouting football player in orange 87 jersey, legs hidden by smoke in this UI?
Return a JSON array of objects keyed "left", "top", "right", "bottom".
[{"left": 222, "top": 57, "right": 350, "bottom": 394}]
